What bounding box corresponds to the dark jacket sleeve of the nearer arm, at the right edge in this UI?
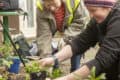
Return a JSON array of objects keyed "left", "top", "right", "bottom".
[{"left": 87, "top": 17, "right": 120, "bottom": 74}]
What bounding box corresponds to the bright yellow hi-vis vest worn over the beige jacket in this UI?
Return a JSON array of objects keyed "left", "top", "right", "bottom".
[{"left": 37, "top": 0, "right": 80, "bottom": 25}]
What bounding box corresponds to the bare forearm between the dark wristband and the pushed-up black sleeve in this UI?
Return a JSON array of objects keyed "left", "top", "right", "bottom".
[{"left": 55, "top": 45, "right": 73, "bottom": 62}]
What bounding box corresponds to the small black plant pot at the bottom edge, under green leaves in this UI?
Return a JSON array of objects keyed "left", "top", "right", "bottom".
[{"left": 30, "top": 71, "right": 47, "bottom": 80}]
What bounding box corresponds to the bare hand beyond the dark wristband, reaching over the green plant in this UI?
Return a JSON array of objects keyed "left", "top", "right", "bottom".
[{"left": 39, "top": 57, "right": 54, "bottom": 67}]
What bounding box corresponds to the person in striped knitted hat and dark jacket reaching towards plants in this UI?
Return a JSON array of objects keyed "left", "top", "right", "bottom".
[{"left": 40, "top": 0, "right": 120, "bottom": 80}]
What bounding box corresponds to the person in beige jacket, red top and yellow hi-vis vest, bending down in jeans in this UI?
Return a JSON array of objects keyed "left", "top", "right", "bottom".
[{"left": 37, "top": 0, "right": 88, "bottom": 72}]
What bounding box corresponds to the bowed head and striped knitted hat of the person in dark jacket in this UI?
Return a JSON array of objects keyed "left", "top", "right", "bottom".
[{"left": 84, "top": 0, "right": 116, "bottom": 23}]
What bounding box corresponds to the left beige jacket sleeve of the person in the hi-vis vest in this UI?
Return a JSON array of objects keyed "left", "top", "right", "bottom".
[{"left": 37, "top": 9, "right": 52, "bottom": 54}]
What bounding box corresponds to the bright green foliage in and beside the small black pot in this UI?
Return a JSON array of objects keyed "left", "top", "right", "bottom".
[{"left": 25, "top": 61, "right": 62, "bottom": 80}]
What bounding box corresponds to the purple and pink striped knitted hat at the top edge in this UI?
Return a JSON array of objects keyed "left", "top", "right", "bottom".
[{"left": 84, "top": 0, "right": 116, "bottom": 7}]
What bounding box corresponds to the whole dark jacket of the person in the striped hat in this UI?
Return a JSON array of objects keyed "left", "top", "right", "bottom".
[{"left": 70, "top": 3, "right": 120, "bottom": 80}]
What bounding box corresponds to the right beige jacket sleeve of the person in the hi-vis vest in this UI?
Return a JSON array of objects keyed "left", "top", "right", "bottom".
[{"left": 65, "top": 0, "right": 89, "bottom": 36}]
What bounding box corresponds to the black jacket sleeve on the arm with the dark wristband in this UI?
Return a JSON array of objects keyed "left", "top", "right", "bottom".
[{"left": 69, "top": 19, "right": 97, "bottom": 54}]
